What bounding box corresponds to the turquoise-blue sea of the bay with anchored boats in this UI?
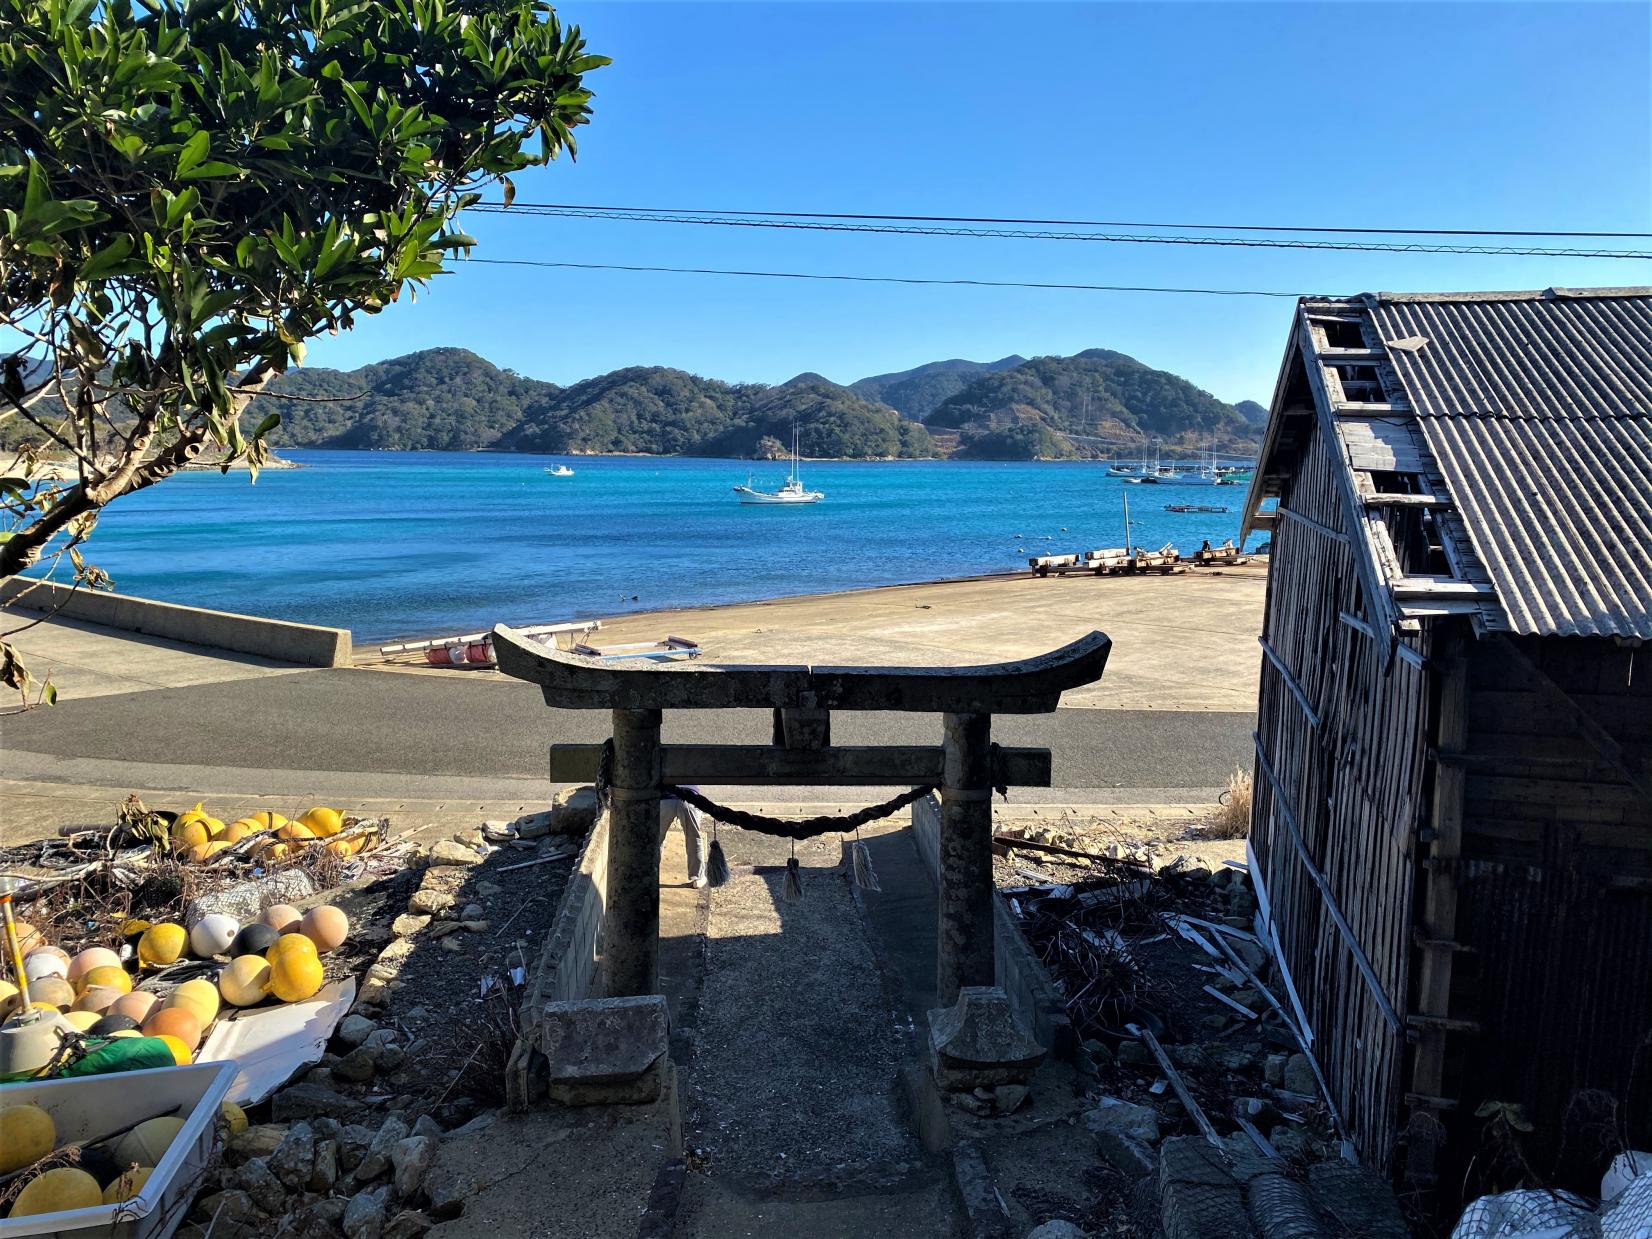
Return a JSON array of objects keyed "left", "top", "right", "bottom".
[{"left": 61, "top": 449, "right": 1244, "bottom": 641}]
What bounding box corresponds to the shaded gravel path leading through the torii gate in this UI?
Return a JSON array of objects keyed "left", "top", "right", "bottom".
[{"left": 687, "top": 828, "right": 922, "bottom": 1188}]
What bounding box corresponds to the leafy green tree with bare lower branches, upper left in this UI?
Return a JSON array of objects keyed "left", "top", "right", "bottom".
[{"left": 0, "top": 0, "right": 608, "bottom": 700}]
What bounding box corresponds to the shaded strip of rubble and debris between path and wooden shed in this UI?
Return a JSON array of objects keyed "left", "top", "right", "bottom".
[{"left": 1001, "top": 839, "right": 1408, "bottom": 1239}]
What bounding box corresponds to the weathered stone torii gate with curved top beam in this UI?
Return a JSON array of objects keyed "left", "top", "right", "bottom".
[{"left": 494, "top": 626, "right": 1112, "bottom": 1006}]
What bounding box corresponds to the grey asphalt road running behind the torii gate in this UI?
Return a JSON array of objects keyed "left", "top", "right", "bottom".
[{"left": 0, "top": 669, "right": 1252, "bottom": 788}]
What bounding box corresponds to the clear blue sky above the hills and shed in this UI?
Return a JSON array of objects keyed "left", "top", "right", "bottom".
[{"left": 309, "top": 0, "right": 1652, "bottom": 403}]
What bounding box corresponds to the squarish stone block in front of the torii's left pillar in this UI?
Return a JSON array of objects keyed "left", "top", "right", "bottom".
[{"left": 540, "top": 995, "right": 671, "bottom": 1105}]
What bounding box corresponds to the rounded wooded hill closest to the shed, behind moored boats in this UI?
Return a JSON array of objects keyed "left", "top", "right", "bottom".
[{"left": 925, "top": 349, "right": 1256, "bottom": 459}]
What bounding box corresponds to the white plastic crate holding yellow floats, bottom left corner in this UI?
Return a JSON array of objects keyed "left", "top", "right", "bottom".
[{"left": 0, "top": 1062, "right": 235, "bottom": 1239}]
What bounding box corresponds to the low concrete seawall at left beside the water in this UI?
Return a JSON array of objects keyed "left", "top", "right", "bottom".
[{"left": 0, "top": 577, "right": 350, "bottom": 667}]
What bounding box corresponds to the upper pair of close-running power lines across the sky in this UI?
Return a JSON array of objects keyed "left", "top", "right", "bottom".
[{"left": 471, "top": 203, "right": 1652, "bottom": 259}]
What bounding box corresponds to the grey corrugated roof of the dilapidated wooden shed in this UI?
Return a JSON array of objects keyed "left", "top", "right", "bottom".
[{"left": 1350, "top": 289, "right": 1652, "bottom": 639}]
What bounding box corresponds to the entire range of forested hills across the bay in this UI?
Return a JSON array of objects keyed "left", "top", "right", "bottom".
[{"left": 241, "top": 349, "right": 1265, "bottom": 459}]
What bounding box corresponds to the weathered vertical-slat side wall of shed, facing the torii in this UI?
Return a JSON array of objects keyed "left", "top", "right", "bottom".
[{"left": 1251, "top": 431, "right": 1431, "bottom": 1170}]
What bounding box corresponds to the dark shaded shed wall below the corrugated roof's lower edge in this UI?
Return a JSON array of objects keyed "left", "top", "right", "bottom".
[{"left": 1450, "top": 638, "right": 1652, "bottom": 1186}]
